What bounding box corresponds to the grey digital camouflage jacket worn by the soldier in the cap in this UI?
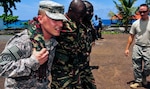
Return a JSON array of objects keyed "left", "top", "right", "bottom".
[{"left": 0, "top": 20, "right": 57, "bottom": 89}]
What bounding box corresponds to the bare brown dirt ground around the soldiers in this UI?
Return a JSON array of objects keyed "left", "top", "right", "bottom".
[{"left": 0, "top": 34, "right": 150, "bottom": 89}]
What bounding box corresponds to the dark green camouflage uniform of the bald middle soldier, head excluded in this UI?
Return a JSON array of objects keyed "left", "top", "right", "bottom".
[{"left": 51, "top": 16, "right": 93, "bottom": 89}]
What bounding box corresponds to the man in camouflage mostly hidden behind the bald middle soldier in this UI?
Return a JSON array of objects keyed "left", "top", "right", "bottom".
[{"left": 80, "top": 0, "right": 96, "bottom": 89}]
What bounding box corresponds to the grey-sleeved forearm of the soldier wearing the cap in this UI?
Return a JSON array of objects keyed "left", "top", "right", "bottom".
[{"left": 0, "top": 57, "right": 39, "bottom": 77}]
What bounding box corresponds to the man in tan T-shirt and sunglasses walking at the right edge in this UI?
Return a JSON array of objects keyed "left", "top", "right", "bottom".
[{"left": 125, "top": 4, "right": 150, "bottom": 88}]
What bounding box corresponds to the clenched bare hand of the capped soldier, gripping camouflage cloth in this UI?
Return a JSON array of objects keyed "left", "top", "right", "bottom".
[{"left": 32, "top": 48, "right": 49, "bottom": 65}]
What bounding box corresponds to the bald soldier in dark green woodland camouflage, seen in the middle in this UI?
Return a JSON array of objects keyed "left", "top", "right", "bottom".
[{"left": 51, "top": 0, "right": 96, "bottom": 89}]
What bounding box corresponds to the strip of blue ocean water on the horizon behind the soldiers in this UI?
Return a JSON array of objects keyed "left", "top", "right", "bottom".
[{"left": 0, "top": 19, "right": 111, "bottom": 30}]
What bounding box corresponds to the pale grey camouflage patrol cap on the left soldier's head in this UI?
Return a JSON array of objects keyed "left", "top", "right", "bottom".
[{"left": 39, "top": 0, "right": 67, "bottom": 20}]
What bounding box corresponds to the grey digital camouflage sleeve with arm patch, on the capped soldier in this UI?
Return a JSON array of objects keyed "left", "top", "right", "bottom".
[{"left": 0, "top": 36, "right": 40, "bottom": 77}]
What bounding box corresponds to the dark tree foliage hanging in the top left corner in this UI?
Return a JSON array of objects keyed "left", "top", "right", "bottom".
[{"left": 0, "top": 0, "right": 21, "bottom": 16}]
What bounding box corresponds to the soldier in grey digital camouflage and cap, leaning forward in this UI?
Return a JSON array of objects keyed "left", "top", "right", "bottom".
[{"left": 0, "top": 0, "right": 66, "bottom": 89}]
